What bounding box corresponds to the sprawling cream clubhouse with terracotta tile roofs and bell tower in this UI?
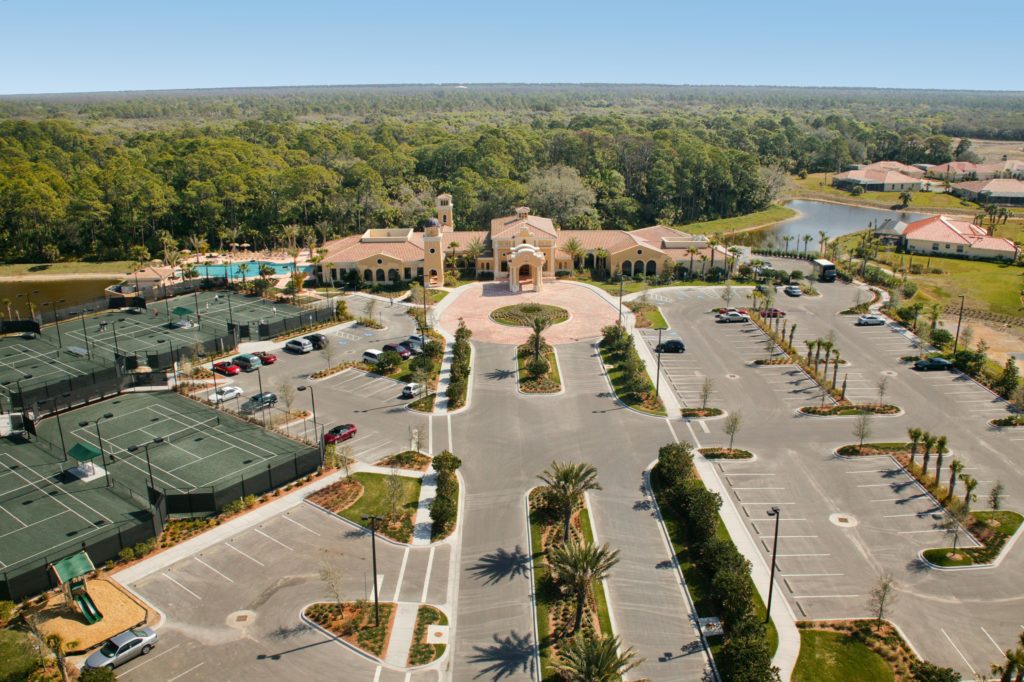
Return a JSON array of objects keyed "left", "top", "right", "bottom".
[{"left": 317, "top": 194, "right": 729, "bottom": 291}]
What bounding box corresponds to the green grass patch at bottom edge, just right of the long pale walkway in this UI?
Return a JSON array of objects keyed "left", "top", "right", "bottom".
[{"left": 793, "top": 630, "right": 895, "bottom": 682}]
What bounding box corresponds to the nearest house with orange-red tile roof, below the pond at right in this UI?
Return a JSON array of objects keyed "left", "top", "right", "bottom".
[{"left": 903, "top": 215, "right": 1020, "bottom": 261}]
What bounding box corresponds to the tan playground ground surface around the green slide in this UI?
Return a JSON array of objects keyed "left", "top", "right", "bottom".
[{"left": 36, "top": 579, "right": 150, "bottom": 653}]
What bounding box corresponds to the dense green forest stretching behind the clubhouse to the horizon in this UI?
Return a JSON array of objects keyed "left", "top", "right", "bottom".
[{"left": 0, "top": 86, "right": 1020, "bottom": 261}]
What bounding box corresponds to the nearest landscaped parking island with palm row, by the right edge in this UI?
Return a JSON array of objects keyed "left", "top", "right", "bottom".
[{"left": 836, "top": 438, "right": 1024, "bottom": 567}]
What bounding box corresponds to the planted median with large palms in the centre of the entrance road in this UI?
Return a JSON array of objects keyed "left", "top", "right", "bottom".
[{"left": 527, "top": 462, "right": 639, "bottom": 681}]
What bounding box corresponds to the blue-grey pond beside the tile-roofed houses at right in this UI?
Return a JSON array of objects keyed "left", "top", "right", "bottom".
[{"left": 736, "top": 200, "right": 928, "bottom": 251}]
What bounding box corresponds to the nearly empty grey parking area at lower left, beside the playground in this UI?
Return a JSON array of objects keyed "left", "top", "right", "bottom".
[{"left": 116, "top": 503, "right": 451, "bottom": 681}]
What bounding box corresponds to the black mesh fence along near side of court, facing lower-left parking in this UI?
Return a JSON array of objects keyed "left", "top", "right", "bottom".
[{"left": 160, "top": 447, "right": 321, "bottom": 516}]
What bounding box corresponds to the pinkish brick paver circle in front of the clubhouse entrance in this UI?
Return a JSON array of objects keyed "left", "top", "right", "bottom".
[{"left": 440, "top": 282, "right": 618, "bottom": 345}]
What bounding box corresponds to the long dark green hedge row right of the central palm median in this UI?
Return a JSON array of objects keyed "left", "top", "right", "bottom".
[{"left": 650, "top": 442, "right": 778, "bottom": 680}]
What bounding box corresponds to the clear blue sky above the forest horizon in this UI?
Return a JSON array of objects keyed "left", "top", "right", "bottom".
[{"left": 0, "top": 0, "right": 1024, "bottom": 94}]
